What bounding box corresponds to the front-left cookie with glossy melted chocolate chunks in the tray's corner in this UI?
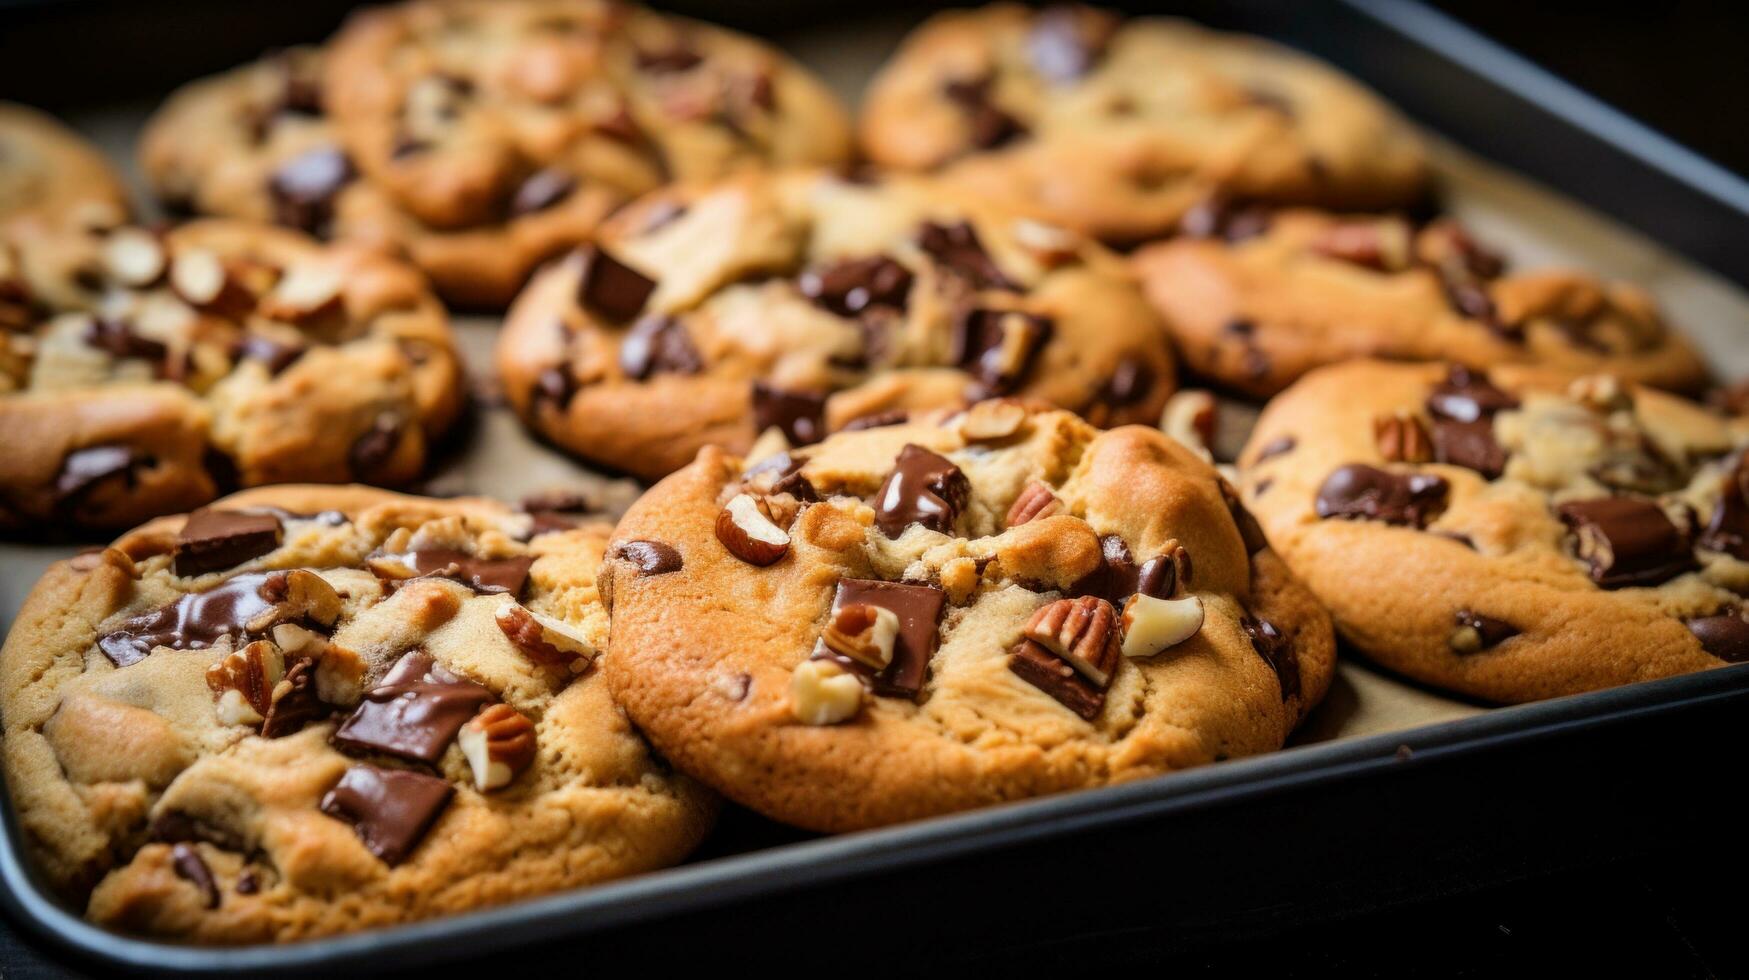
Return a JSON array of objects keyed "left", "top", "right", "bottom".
[{"left": 0, "top": 487, "right": 715, "bottom": 943}]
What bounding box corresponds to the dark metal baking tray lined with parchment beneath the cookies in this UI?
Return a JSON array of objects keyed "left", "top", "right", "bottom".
[{"left": 0, "top": 0, "right": 1749, "bottom": 975}]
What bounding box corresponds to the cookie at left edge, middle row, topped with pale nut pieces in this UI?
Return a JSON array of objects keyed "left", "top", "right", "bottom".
[{"left": 0, "top": 221, "right": 463, "bottom": 532}]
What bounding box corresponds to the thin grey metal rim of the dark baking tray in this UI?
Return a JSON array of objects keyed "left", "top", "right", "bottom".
[{"left": 0, "top": 0, "right": 1749, "bottom": 975}]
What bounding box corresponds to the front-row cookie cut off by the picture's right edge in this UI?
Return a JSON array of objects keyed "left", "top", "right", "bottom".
[{"left": 1240, "top": 361, "right": 1749, "bottom": 702}]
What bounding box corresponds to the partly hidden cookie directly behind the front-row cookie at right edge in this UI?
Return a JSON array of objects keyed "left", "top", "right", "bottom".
[{"left": 1135, "top": 210, "right": 1709, "bottom": 397}]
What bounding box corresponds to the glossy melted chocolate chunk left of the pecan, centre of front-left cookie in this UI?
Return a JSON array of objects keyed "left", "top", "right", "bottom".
[{"left": 334, "top": 651, "right": 495, "bottom": 765}]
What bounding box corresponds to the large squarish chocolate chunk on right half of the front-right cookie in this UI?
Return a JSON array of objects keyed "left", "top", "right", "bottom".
[{"left": 1560, "top": 497, "right": 1695, "bottom": 588}]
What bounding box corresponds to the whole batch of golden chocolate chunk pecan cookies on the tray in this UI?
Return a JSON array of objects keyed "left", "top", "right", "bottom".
[{"left": 0, "top": 0, "right": 1749, "bottom": 943}]
